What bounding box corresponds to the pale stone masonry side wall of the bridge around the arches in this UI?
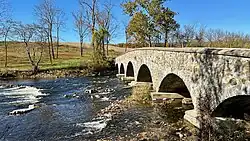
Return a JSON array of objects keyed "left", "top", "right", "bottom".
[{"left": 116, "top": 48, "right": 250, "bottom": 110}]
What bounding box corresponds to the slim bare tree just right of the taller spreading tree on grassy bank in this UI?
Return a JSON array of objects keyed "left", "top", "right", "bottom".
[{"left": 55, "top": 10, "right": 65, "bottom": 58}]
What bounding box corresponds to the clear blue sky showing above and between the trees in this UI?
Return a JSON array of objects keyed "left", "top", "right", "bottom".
[{"left": 9, "top": 0, "right": 250, "bottom": 43}]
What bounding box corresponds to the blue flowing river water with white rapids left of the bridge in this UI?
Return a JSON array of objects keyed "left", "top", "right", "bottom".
[{"left": 0, "top": 76, "right": 130, "bottom": 141}]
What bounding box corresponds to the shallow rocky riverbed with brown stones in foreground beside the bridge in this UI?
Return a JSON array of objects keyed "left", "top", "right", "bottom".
[{"left": 79, "top": 99, "right": 197, "bottom": 141}]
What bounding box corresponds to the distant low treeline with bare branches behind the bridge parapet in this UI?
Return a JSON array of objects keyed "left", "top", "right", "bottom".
[{"left": 115, "top": 25, "right": 250, "bottom": 48}]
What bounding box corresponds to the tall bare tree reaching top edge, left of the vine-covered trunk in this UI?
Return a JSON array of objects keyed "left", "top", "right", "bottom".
[{"left": 79, "top": 0, "right": 98, "bottom": 50}]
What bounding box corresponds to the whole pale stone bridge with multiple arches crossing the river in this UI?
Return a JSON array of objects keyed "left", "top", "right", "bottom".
[{"left": 116, "top": 48, "right": 250, "bottom": 126}]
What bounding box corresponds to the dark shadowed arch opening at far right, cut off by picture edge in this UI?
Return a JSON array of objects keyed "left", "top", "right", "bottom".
[{"left": 212, "top": 95, "right": 250, "bottom": 120}]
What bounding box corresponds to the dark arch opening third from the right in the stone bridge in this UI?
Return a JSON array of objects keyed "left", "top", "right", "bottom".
[{"left": 137, "top": 64, "right": 152, "bottom": 82}]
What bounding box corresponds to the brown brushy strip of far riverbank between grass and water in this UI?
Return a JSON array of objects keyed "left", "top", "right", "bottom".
[{"left": 0, "top": 58, "right": 116, "bottom": 79}]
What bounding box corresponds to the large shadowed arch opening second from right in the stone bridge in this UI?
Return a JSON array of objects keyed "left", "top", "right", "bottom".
[{"left": 159, "top": 73, "right": 191, "bottom": 98}]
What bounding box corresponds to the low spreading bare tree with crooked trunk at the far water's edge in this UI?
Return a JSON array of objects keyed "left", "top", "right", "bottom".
[{"left": 16, "top": 24, "right": 47, "bottom": 74}]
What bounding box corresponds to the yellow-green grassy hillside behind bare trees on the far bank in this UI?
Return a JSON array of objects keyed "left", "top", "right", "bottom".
[{"left": 0, "top": 43, "right": 119, "bottom": 71}]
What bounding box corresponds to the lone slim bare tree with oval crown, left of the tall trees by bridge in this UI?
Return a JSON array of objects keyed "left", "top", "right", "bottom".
[{"left": 72, "top": 9, "right": 88, "bottom": 56}]
